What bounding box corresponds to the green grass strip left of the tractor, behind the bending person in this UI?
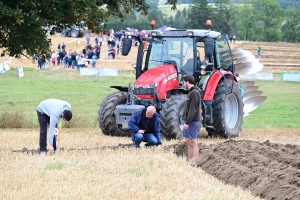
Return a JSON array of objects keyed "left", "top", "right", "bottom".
[{"left": 0, "top": 68, "right": 134, "bottom": 127}]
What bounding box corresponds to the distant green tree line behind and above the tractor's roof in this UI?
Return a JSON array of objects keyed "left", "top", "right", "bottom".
[{"left": 107, "top": 0, "right": 300, "bottom": 42}]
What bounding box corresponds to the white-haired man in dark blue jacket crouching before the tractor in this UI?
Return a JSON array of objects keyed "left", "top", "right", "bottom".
[{"left": 128, "top": 106, "right": 162, "bottom": 147}]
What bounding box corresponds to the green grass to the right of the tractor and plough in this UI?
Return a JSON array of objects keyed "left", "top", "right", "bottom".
[{"left": 243, "top": 77, "right": 300, "bottom": 128}]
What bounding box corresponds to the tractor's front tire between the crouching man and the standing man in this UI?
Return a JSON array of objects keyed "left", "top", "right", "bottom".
[{"left": 160, "top": 94, "right": 187, "bottom": 139}]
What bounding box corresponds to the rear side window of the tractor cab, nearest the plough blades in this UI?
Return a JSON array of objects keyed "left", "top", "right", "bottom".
[{"left": 217, "top": 36, "right": 232, "bottom": 69}]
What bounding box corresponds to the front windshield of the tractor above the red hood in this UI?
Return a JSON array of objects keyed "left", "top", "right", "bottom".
[{"left": 148, "top": 37, "right": 194, "bottom": 73}]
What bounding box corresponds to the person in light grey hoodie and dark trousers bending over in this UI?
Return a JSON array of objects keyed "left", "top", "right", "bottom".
[{"left": 37, "top": 99, "right": 72, "bottom": 154}]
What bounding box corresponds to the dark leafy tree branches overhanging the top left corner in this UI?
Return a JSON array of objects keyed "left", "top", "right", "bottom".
[{"left": 0, "top": 0, "right": 177, "bottom": 58}]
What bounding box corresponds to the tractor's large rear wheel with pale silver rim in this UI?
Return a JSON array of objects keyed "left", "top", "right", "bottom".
[{"left": 212, "top": 80, "right": 244, "bottom": 138}]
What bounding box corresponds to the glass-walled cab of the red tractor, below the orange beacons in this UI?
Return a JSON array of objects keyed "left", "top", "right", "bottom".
[{"left": 123, "top": 26, "right": 234, "bottom": 93}]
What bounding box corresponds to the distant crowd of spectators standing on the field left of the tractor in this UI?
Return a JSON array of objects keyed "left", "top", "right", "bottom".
[{"left": 32, "top": 28, "right": 149, "bottom": 69}]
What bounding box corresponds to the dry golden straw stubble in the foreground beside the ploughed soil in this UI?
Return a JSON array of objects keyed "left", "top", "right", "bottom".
[{"left": 0, "top": 129, "right": 299, "bottom": 199}]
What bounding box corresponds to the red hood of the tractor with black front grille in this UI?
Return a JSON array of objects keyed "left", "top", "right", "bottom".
[{"left": 134, "top": 64, "right": 179, "bottom": 99}]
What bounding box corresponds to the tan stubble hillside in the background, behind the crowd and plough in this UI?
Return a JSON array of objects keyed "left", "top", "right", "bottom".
[{"left": 0, "top": 35, "right": 300, "bottom": 74}]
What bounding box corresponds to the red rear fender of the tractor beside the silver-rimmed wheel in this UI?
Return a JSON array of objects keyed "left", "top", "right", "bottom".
[{"left": 202, "top": 70, "right": 232, "bottom": 101}]
